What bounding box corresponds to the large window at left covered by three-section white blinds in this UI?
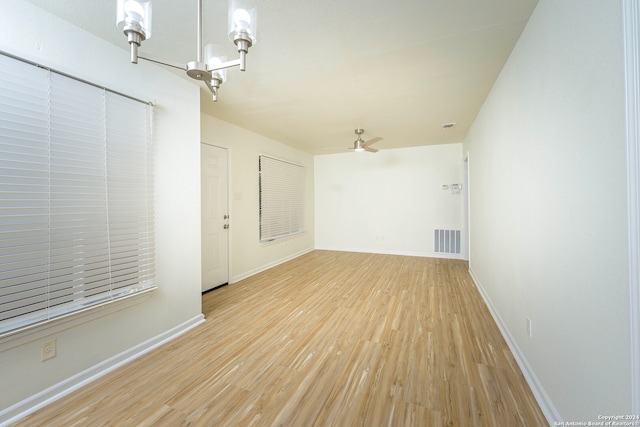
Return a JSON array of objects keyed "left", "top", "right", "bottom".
[{"left": 0, "top": 55, "right": 155, "bottom": 335}]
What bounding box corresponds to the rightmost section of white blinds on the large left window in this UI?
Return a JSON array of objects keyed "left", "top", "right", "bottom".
[{"left": 106, "top": 93, "right": 155, "bottom": 296}]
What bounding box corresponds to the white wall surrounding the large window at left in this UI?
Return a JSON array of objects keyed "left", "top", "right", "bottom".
[{"left": 0, "top": 0, "right": 201, "bottom": 418}]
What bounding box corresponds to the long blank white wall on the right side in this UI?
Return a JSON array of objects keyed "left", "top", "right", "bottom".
[{"left": 465, "top": 0, "right": 631, "bottom": 421}]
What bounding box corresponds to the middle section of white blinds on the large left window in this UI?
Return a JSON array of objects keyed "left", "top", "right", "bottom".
[{"left": 49, "top": 73, "right": 110, "bottom": 314}]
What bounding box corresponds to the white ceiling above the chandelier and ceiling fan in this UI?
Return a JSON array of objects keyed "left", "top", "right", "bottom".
[{"left": 22, "top": 0, "right": 537, "bottom": 155}]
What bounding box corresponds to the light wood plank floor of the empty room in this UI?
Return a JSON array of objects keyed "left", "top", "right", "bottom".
[{"left": 18, "top": 251, "right": 548, "bottom": 427}]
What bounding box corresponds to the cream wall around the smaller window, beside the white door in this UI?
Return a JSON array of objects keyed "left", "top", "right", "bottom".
[{"left": 201, "top": 114, "right": 314, "bottom": 283}]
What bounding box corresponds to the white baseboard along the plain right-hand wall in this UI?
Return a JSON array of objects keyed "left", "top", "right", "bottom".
[{"left": 469, "top": 268, "right": 562, "bottom": 426}]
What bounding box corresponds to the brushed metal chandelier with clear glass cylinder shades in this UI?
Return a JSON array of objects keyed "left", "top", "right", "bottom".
[{"left": 116, "top": 0, "right": 257, "bottom": 101}]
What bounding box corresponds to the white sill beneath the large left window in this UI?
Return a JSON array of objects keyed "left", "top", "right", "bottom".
[{"left": 0, "top": 286, "right": 157, "bottom": 352}]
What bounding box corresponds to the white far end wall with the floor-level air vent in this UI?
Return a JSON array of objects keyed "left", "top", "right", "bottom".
[{"left": 315, "top": 144, "right": 464, "bottom": 257}]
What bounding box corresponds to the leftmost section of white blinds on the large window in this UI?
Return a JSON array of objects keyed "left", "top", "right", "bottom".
[{"left": 0, "top": 55, "right": 49, "bottom": 328}]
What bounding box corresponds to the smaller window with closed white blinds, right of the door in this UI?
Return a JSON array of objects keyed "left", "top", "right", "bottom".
[{"left": 258, "top": 155, "right": 305, "bottom": 242}]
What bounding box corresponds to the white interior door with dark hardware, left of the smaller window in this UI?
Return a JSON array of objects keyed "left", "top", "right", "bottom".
[{"left": 200, "top": 144, "right": 229, "bottom": 292}]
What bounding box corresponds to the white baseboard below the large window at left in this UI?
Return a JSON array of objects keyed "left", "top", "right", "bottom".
[{"left": 0, "top": 314, "right": 205, "bottom": 427}]
